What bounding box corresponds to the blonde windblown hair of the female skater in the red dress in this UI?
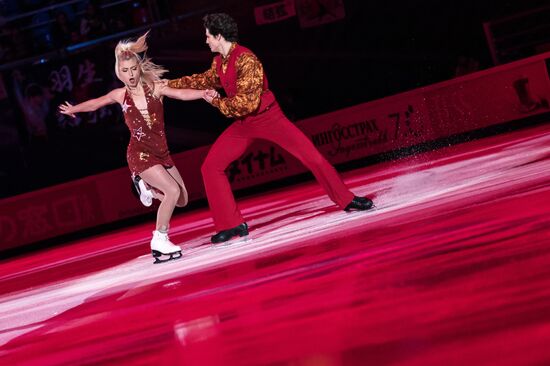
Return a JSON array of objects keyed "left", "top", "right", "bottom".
[{"left": 115, "top": 31, "right": 168, "bottom": 90}]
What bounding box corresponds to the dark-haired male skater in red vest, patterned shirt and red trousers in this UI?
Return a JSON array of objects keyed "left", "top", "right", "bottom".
[{"left": 168, "top": 13, "right": 373, "bottom": 243}]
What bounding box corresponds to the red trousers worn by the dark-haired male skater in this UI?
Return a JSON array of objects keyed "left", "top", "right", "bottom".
[{"left": 201, "top": 103, "right": 354, "bottom": 231}]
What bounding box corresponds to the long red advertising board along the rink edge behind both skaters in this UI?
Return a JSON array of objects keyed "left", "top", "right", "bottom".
[{"left": 0, "top": 53, "right": 550, "bottom": 250}]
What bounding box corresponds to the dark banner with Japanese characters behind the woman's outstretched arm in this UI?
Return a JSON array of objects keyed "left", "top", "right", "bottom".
[{"left": 7, "top": 46, "right": 121, "bottom": 135}]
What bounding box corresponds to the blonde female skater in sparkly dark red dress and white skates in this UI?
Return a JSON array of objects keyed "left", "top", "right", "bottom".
[{"left": 59, "top": 33, "right": 209, "bottom": 263}]
